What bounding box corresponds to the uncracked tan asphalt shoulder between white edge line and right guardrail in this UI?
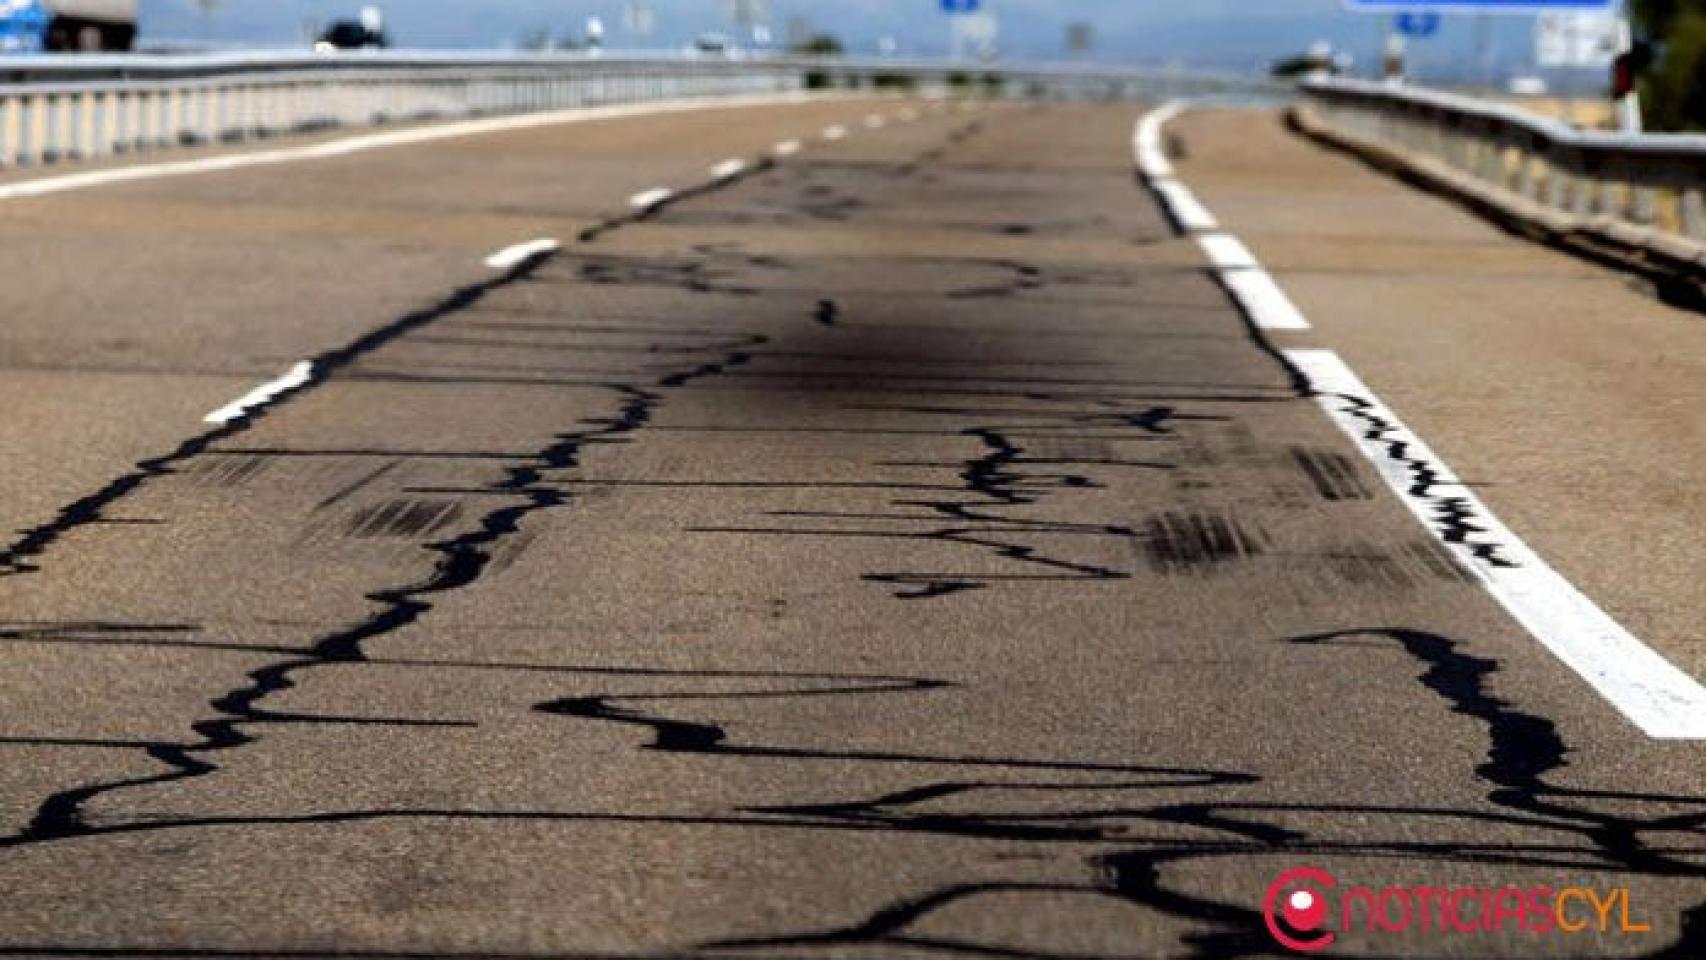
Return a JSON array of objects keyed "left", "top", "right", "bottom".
[{"left": 1170, "top": 111, "right": 1706, "bottom": 677}]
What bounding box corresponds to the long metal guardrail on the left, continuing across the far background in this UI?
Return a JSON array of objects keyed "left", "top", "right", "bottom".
[{"left": 0, "top": 51, "right": 1283, "bottom": 167}]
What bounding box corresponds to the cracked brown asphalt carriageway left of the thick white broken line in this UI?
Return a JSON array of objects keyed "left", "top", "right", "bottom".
[{"left": 0, "top": 104, "right": 1706, "bottom": 958}]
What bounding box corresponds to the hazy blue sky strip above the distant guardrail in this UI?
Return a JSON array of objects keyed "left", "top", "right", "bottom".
[{"left": 142, "top": 0, "right": 1589, "bottom": 75}]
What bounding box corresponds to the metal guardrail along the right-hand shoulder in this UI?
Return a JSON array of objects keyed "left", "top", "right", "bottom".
[{"left": 1302, "top": 78, "right": 1706, "bottom": 244}]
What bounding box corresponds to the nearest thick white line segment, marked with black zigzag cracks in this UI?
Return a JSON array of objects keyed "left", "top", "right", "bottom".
[{"left": 1285, "top": 350, "right": 1706, "bottom": 740}]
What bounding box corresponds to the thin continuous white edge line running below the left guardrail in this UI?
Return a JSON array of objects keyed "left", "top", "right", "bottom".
[{"left": 0, "top": 90, "right": 825, "bottom": 200}]
